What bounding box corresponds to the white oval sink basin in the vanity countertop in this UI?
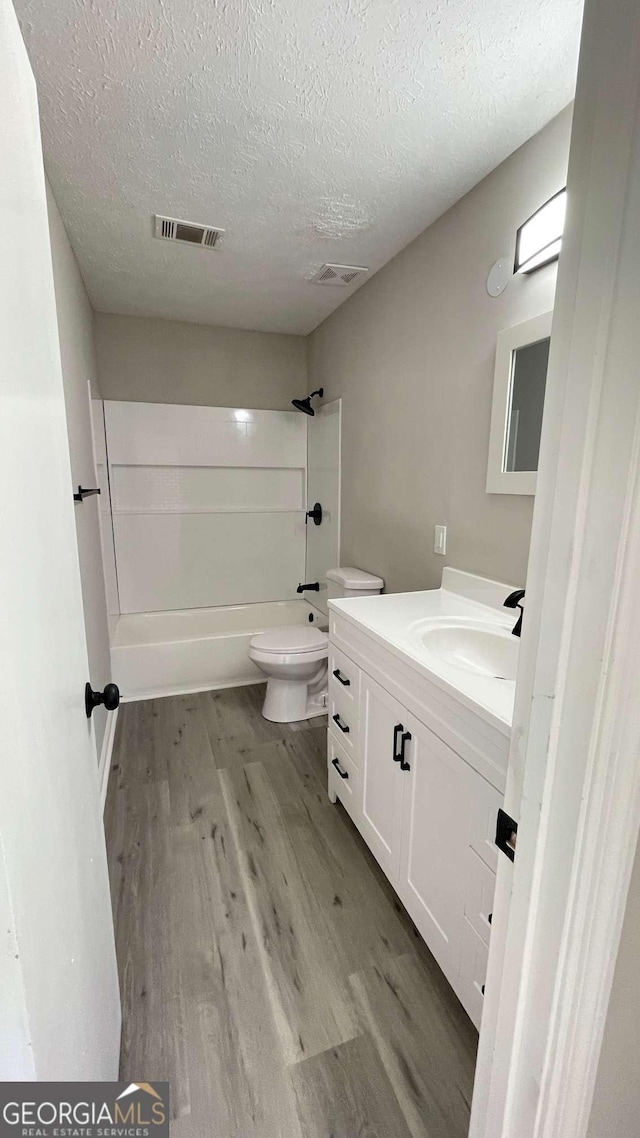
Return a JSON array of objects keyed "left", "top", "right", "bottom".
[{"left": 411, "top": 620, "right": 519, "bottom": 681}]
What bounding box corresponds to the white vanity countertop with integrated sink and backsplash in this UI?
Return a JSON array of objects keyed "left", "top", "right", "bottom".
[{"left": 329, "top": 568, "right": 519, "bottom": 735}]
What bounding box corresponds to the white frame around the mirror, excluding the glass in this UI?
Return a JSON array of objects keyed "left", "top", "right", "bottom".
[{"left": 486, "top": 312, "right": 553, "bottom": 494}]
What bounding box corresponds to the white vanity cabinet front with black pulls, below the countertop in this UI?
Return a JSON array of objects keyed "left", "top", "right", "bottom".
[{"left": 329, "top": 613, "right": 508, "bottom": 1026}]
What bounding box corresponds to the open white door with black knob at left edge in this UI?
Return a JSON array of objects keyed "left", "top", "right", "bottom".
[{"left": 0, "top": 0, "right": 120, "bottom": 1080}]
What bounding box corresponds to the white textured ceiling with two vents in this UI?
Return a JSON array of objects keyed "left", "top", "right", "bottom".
[{"left": 16, "top": 0, "right": 582, "bottom": 333}]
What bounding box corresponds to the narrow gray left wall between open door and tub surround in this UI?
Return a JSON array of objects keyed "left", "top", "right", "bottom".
[{"left": 44, "top": 184, "right": 110, "bottom": 757}]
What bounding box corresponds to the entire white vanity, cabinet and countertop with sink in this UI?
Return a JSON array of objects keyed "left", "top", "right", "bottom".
[{"left": 328, "top": 569, "right": 517, "bottom": 1026}]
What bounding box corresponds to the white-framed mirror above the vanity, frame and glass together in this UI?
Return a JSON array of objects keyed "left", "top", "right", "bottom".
[{"left": 486, "top": 312, "right": 551, "bottom": 494}]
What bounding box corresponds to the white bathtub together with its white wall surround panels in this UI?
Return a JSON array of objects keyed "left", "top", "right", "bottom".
[{"left": 95, "top": 401, "right": 340, "bottom": 699}]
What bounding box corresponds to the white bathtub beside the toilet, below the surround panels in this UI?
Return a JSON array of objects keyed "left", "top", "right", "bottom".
[{"left": 112, "top": 599, "right": 328, "bottom": 701}]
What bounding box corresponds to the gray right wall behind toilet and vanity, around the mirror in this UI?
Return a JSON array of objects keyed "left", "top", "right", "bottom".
[{"left": 307, "top": 108, "right": 571, "bottom": 591}]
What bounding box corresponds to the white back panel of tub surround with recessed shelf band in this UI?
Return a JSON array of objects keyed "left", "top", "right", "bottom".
[{"left": 105, "top": 402, "right": 306, "bottom": 613}]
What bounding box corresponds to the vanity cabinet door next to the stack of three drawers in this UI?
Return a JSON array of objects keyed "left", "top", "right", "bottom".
[{"left": 360, "top": 673, "right": 407, "bottom": 884}]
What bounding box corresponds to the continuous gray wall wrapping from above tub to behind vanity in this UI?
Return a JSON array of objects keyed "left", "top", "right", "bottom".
[{"left": 95, "top": 108, "right": 571, "bottom": 589}]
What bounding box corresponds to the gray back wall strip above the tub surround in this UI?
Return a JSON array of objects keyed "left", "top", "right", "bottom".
[{"left": 95, "top": 313, "right": 307, "bottom": 411}]
